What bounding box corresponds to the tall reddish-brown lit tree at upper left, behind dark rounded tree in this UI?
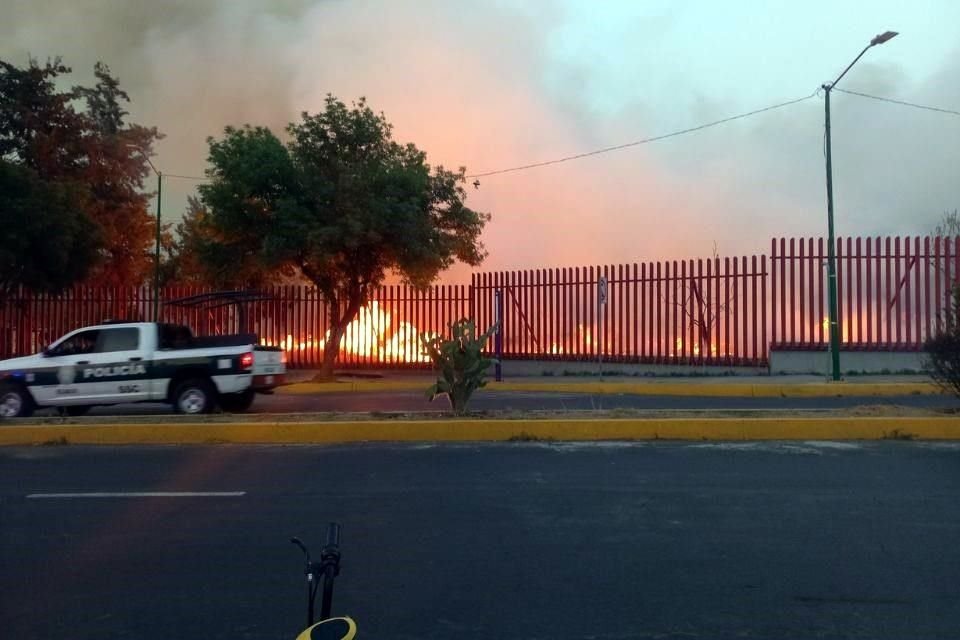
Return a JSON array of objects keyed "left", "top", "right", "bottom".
[{"left": 0, "top": 59, "right": 160, "bottom": 285}]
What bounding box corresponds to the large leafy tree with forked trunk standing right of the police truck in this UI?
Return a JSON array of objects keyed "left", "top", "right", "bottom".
[{"left": 198, "top": 96, "right": 490, "bottom": 375}]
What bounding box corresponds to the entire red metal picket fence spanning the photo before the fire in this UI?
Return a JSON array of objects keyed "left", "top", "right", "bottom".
[{"left": 0, "top": 237, "right": 960, "bottom": 367}]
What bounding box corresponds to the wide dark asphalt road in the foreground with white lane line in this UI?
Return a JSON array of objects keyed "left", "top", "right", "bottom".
[{"left": 0, "top": 441, "right": 960, "bottom": 640}]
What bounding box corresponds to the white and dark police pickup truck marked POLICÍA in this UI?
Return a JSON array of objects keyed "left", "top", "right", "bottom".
[{"left": 0, "top": 322, "right": 286, "bottom": 418}]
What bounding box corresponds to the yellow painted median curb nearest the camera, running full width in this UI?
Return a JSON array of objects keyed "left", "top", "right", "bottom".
[{"left": 0, "top": 416, "right": 960, "bottom": 445}]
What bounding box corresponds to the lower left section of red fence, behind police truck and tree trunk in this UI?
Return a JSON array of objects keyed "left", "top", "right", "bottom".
[{"left": 0, "top": 285, "right": 470, "bottom": 367}]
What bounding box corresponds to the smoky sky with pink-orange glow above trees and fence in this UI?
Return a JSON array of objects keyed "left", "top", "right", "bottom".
[{"left": 0, "top": 0, "right": 960, "bottom": 282}]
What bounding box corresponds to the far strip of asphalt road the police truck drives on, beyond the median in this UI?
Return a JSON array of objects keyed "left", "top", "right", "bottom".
[{"left": 24, "top": 390, "right": 960, "bottom": 416}]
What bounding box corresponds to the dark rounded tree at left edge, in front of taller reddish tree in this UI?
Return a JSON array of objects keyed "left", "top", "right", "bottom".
[{"left": 0, "top": 160, "right": 100, "bottom": 304}]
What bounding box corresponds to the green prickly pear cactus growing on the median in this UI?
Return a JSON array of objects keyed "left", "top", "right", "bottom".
[{"left": 420, "top": 319, "right": 497, "bottom": 415}]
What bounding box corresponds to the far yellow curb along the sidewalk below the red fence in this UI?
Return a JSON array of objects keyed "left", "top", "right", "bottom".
[{"left": 276, "top": 380, "right": 943, "bottom": 398}]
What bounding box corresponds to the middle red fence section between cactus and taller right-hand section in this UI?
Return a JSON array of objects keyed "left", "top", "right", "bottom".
[{"left": 473, "top": 256, "right": 767, "bottom": 365}]
